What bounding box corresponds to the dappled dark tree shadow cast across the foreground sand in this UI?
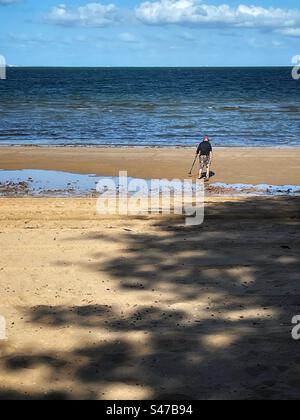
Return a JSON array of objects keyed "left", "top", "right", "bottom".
[{"left": 0, "top": 197, "right": 300, "bottom": 400}]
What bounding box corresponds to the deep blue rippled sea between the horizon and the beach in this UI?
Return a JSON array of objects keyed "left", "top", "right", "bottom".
[{"left": 0, "top": 68, "right": 300, "bottom": 147}]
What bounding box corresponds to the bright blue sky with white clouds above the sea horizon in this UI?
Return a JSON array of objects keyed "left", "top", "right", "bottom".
[{"left": 0, "top": 0, "right": 300, "bottom": 66}]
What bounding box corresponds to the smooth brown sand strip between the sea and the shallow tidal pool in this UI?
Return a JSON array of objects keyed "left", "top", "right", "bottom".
[{"left": 0, "top": 147, "right": 300, "bottom": 185}]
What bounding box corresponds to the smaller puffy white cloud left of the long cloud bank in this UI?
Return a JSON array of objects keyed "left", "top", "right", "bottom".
[{"left": 44, "top": 3, "right": 118, "bottom": 27}]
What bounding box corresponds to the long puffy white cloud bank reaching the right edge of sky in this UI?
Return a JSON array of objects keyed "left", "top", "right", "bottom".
[{"left": 136, "top": 0, "right": 300, "bottom": 29}]
